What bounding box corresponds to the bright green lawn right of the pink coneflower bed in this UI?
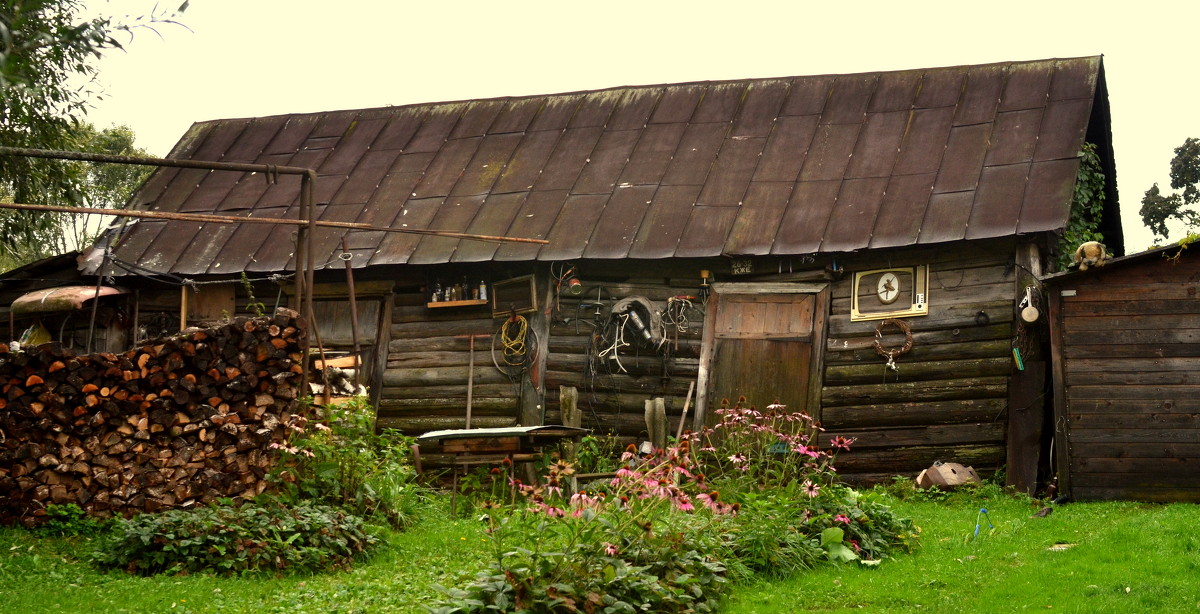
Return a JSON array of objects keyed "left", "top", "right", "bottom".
[{"left": 724, "top": 489, "right": 1200, "bottom": 614}]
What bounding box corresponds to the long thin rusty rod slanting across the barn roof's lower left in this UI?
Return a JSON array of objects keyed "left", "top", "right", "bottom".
[{"left": 0, "top": 203, "right": 550, "bottom": 245}]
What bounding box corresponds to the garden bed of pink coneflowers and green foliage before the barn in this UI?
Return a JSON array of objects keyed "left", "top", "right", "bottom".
[{"left": 430, "top": 399, "right": 916, "bottom": 614}]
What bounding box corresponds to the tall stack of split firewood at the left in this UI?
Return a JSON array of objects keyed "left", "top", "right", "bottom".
[{"left": 0, "top": 309, "right": 307, "bottom": 524}]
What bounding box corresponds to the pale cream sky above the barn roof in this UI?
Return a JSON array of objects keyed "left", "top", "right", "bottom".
[{"left": 86, "top": 0, "right": 1200, "bottom": 253}]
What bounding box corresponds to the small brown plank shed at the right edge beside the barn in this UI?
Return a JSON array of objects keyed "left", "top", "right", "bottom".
[{"left": 1045, "top": 246, "right": 1200, "bottom": 501}]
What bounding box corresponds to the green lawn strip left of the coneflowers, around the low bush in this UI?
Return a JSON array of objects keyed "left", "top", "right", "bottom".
[{"left": 0, "top": 518, "right": 485, "bottom": 614}]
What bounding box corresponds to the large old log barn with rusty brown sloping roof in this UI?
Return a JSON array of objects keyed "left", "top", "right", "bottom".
[{"left": 4, "top": 56, "right": 1122, "bottom": 488}]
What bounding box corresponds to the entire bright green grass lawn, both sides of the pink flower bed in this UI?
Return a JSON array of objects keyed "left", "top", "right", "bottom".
[{"left": 0, "top": 489, "right": 1200, "bottom": 614}]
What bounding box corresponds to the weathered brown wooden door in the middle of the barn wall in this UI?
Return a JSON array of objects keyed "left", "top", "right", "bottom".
[{"left": 706, "top": 293, "right": 816, "bottom": 419}]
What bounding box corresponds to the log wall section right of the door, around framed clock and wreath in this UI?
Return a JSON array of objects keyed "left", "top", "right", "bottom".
[{"left": 820, "top": 243, "right": 1016, "bottom": 482}]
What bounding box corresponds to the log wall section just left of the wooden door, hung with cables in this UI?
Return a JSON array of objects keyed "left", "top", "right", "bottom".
[{"left": 546, "top": 278, "right": 704, "bottom": 440}]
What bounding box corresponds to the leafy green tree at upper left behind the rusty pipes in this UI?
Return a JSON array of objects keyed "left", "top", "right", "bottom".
[{"left": 0, "top": 0, "right": 187, "bottom": 266}]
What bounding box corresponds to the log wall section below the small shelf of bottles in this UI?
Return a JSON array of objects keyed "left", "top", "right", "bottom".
[{"left": 378, "top": 288, "right": 518, "bottom": 435}]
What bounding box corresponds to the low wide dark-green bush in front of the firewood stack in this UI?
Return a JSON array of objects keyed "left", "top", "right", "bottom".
[{"left": 92, "top": 502, "right": 378, "bottom": 576}]
